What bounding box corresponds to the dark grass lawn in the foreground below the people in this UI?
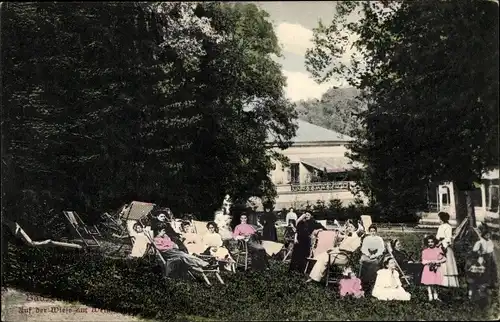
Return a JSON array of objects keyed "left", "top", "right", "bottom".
[{"left": 4, "top": 235, "right": 498, "bottom": 321}]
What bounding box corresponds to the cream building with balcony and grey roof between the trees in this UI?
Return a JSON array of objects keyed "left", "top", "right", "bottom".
[{"left": 270, "top": 120, "right": 366, "bottom": 209}]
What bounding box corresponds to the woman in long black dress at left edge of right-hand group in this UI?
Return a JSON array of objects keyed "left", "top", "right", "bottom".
[{"left": 290, "top": 212, "right": 326, "bottom": 273}]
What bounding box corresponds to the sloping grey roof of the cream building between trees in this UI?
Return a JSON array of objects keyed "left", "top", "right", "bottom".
[{"left": 267, "top": 120, "right": 354, "bottom": 143}]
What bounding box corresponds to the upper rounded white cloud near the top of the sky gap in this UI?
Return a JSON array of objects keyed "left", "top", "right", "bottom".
[{"left": 276, "top": 22, "right": 313, "bottom": 56}]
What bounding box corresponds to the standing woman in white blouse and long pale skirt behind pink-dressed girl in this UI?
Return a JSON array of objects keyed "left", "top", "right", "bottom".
[{"left": 436, "top": 212, "right": 459, "bottom": 287}]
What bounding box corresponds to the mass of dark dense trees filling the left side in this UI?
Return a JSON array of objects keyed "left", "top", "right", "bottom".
[{"left": 1, "top": 2, "right": 296, "bottom": 234}]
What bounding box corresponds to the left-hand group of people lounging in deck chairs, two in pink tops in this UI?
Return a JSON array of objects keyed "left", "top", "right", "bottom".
[{"left": 130, "top": 208, "right": 269, "bottom": 277}]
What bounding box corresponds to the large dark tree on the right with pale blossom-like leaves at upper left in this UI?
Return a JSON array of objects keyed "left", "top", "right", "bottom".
[{"left": 307, "top": 0, "right": 499, "bottom": 219}]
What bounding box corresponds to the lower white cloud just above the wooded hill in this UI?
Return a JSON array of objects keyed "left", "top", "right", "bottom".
[{"left": 283, "top": 70, "right": 344, "bottom": 102}]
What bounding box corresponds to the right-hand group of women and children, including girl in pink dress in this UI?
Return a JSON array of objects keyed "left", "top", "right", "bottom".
[{"left": 290, "top": 213, "right": 497, "bottom": 301}]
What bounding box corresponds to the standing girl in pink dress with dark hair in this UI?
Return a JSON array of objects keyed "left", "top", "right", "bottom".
[{"left": 421, "top": 236, "right": 446, "bottom": 301}]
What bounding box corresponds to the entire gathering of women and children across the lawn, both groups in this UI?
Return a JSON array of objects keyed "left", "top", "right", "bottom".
[{"left": 128, "top": 209, "right": 496, "bottom": 301}]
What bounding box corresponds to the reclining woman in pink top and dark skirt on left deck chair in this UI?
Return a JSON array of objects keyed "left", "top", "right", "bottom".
[{"left": 153, "top": 226, "right": 209, "bottom": 277}]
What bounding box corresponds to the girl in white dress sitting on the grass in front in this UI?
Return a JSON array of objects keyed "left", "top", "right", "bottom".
[{"left": 372, "top": 257, "right": 411, "bottom": 301}]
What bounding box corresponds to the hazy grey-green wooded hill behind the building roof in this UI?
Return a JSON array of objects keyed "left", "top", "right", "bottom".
[{"left": 296, "top": 88, "right": 365, "bottom": 136}]
